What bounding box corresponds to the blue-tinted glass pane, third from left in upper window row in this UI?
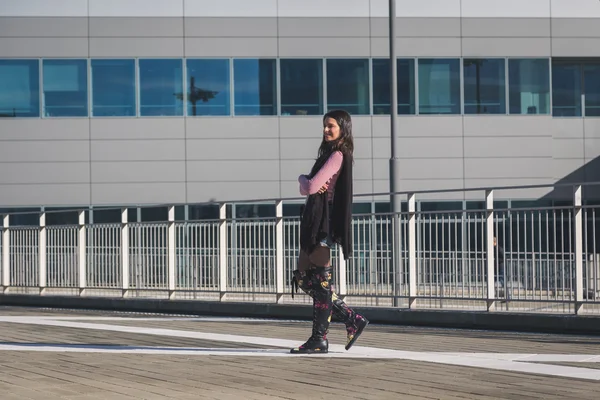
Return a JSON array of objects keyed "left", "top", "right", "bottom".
[{"left": 92, "top": 60, "right": 136, "bottom": 117}]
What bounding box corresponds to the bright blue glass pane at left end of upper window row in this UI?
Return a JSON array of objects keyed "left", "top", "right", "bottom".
[{"left": 0, "top": 60, "right": 40, "bottom": 117}]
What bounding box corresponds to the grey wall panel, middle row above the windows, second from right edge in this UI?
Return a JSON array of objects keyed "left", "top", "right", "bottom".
[{"left": 462, "top": 18, "right": 550, "bottom": 38}]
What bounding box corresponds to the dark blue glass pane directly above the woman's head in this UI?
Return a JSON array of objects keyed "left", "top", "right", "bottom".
[{"left": 327, "top": 59, "right": 370, "bottom": 114}]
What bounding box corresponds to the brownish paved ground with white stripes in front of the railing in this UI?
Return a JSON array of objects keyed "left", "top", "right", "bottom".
[{"left": 0, "top": 307, "right": 600, "bottom": 400}]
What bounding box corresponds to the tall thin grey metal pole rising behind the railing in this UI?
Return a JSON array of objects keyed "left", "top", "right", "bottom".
[{"left": 389, "top": 0, "right": 403, "bottom": 307}]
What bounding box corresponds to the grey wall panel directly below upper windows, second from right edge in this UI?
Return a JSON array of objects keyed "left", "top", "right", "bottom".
[{"left": 464, "top": 115, "right": 555, "bottom": 137}]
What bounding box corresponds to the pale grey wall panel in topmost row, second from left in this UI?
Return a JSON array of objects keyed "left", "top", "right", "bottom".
[{"left": 88, "top": 0, "right": 183, "bottom": 17}]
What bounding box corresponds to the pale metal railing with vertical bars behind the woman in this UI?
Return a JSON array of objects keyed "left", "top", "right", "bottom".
[{"left": 0, "top": 184, "right": 600, "bottom": 314}]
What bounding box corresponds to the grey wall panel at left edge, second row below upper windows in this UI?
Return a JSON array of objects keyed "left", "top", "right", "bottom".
[{"left": 0, "top": 140, "right": 90, "bottom": 162}]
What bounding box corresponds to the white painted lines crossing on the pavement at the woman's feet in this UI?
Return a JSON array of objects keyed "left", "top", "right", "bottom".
[{"left": 0, "top": 316, "right": 600, "bottom": 381}]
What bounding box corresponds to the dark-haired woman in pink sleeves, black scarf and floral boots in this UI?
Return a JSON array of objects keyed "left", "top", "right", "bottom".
[{"left": 291, "top": 110, "right": 369, "bottom": 354}]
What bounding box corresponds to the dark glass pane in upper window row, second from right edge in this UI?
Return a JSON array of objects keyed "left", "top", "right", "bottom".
[{"left": 552, "top": 62, "right": 581, "bottom": 117}]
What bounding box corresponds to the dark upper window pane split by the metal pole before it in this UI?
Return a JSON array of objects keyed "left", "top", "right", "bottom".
[{"left": 373, "top": 59, "right": 415, "bottom": 115}]
